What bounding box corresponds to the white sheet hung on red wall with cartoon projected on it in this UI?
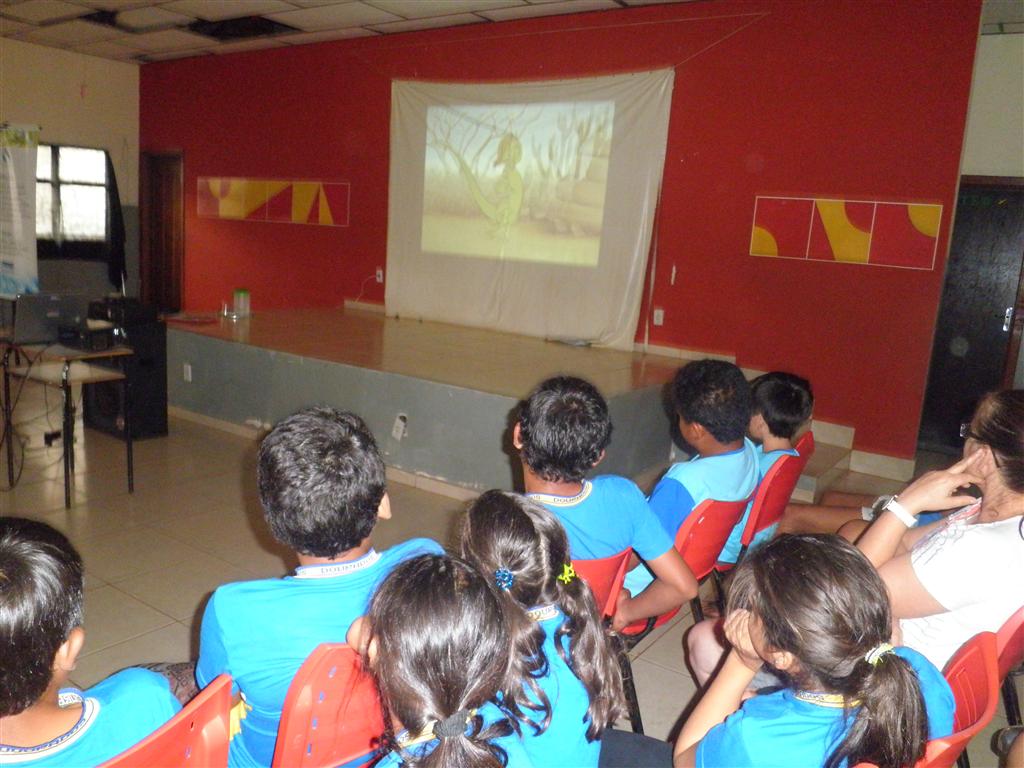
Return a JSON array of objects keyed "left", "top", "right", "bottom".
[{"left": 385, "top": 70, "right": 674, "bottom": 349}]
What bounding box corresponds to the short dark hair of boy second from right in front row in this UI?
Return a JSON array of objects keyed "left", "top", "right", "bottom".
[{"left": 672, "top": 359, "right": 751, "bottom": 442}]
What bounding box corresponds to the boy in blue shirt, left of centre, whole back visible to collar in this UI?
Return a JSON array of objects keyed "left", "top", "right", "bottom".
[{"left": 196, "top": 408, "right": 442, "bottom": 766}]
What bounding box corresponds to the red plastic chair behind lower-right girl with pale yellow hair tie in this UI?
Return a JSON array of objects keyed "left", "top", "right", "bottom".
[{"left": 854, "top": 632, "right": 999, "bottom": 768}]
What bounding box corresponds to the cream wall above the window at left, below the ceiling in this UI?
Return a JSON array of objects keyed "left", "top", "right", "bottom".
[{"left": 0, "top": 39, "right": 138, "bottom": 206}]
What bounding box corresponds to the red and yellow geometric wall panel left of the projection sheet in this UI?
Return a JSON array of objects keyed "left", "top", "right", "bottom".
[{"left": 196, "top": 176, "right": 349, "bottom": 226}]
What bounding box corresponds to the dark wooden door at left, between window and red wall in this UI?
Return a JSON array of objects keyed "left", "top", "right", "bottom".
[{"left": 139, "top": 153, "right": 184, "bottom": 312}]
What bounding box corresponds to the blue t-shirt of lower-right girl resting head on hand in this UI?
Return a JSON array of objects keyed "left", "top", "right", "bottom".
[{"left": 696, "top": 647, "right": 955, "bottom": 768}]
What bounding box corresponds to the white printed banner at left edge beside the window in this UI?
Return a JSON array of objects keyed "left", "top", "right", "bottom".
[{"left": 0, "top": 124, "right": 39, "bottom": 296}]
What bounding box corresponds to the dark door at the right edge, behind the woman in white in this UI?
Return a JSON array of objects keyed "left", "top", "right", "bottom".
[{"left": 919, "top": 179, "right": 1024, "bottom": 454}]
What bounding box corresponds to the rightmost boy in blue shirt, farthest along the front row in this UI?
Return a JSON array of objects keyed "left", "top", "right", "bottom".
[{"left": 718, "top": 371, "right": 814, "bottom": 562}]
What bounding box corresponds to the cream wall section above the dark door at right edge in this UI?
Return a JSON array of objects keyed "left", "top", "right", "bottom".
[{"left": 961, "top": 35, "right": 1024, "bottom": 177}]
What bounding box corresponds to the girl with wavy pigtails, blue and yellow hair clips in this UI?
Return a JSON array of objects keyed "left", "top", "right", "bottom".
[{"left": 462, "top": 490, "right": 668, "bottom": 768}]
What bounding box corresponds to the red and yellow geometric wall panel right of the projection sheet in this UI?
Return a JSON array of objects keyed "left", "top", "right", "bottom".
[{"left": 751, "top": 196, "right": 942, "bottom": 270}]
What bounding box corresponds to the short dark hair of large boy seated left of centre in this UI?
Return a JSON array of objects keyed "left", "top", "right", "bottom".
[{"left": 256, "top": 407, "right": 384, "bottom": 557}]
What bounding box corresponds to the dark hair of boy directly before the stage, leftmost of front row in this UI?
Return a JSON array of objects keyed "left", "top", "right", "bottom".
[{"left": 518, "top": 376, "right": 611, "bottom": 482}]
